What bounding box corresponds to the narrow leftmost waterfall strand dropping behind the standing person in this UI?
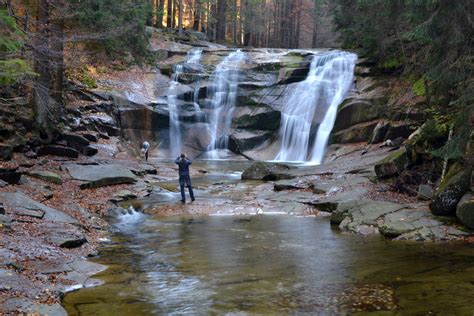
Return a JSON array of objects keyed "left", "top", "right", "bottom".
[{"left": 167, "top": 48, "right": 202, "bottom": 158}]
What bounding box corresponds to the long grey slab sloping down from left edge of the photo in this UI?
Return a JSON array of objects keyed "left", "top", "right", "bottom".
[{"left": 0, "top": 192, "right": 78, "bottom": 224}]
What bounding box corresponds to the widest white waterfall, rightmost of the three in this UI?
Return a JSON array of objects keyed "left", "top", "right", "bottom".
[{"left": 275, "top": 51, "right": 357, "bottom": 164}]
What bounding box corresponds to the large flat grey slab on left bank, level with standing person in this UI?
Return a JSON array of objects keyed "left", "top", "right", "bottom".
[{"left": 66, "top": 164, "right": 137, "bottom": 189}]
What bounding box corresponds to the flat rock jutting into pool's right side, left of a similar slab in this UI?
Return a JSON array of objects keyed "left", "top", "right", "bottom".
[{"left": 331, "top": 200, "right": 405, "bottom": 232}]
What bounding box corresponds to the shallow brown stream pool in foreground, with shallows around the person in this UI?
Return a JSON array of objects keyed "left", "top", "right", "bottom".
[{"left": 63, "top": 161, "right": 474, "bottom": 315}]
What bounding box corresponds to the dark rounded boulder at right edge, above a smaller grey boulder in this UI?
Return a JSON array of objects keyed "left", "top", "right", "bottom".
[{"left": 430, "top": 165, "right": 471, "bottom": 216}]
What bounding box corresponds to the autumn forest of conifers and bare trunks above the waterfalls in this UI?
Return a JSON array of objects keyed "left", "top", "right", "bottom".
[{"left": 0, "top": 0, "right": 474, "bottom": 162}]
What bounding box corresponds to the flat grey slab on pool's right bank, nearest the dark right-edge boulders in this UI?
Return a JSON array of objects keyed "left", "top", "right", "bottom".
[{"left": 379, "top": 210, "right": 443, "bottom": 238}]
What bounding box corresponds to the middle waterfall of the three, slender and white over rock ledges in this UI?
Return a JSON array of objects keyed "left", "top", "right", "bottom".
[{"left": 207, "top": 50, "right": 247, "bottom": 159}]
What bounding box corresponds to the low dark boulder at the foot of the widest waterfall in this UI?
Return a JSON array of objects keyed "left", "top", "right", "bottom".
[{"left": 242, "top": 162, "right": 295, "bottom": 181}]
